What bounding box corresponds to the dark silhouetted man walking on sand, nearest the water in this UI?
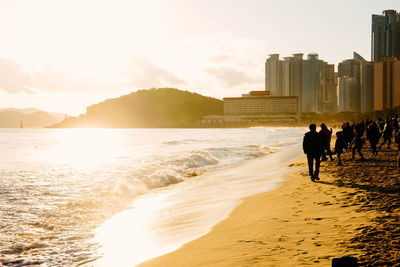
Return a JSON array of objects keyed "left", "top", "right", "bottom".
[{"left": 303, "top": 124, "right": 323, "bottom": 182}]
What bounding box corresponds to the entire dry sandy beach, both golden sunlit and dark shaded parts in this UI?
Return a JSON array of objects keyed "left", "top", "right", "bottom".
[{"left": 140, "top": 146, "right": 400, "bottom": 266}]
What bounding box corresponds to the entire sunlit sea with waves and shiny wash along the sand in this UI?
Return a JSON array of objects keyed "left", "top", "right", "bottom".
[{"left": 0, "top": 127, "right": 305, "bottom": 266}]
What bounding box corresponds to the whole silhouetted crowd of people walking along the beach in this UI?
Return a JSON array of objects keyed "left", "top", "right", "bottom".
[{"left": 303, "top": 116, "right": 400, "bottom": 181}]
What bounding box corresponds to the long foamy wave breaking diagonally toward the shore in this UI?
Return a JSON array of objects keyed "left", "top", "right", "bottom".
[{"left": 68, "top": 151, "right": 219, "bottom": 212}]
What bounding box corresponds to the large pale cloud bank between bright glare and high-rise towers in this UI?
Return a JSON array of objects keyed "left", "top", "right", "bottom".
[{"left": 142, "top": 32, "right": 268, "bottom": 98}]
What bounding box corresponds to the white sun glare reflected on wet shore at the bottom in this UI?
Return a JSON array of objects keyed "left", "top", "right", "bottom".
[{"left": 94, "top": 195, "right": 176, "bottom": 267}]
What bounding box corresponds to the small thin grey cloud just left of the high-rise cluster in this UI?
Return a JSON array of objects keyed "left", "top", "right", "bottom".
[{"left": 205, "top": 67, "right": 263, "bottom": 87}]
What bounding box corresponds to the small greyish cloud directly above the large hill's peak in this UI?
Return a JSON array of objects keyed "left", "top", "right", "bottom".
[{"left": 126, "top": 57, "right": 187, "bottom": 88}]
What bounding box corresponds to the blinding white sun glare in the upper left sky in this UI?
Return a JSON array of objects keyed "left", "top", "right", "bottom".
[{"left": 9, "top": 0, "right": 160, "bottom": 79}]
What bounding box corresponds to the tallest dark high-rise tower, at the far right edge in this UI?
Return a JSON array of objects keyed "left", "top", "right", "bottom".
[{"left": 371, "top": 10, "right": 400, "bottom": 62}]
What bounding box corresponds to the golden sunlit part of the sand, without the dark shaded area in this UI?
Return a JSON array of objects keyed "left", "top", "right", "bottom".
[{"left": 140, "top": 153, "right": 390, "bottom": 266}]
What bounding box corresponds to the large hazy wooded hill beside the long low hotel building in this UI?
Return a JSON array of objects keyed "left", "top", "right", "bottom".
[{"left": 50, "top": 88, "right": 223, "bottom": 128}]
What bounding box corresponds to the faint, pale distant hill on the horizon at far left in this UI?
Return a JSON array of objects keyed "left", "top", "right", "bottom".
[{"left": 0, "top": 109, "right": 64, "bottom": 128}]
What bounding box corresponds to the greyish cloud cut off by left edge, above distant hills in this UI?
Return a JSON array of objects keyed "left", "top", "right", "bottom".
[{"left": 0, "top": 58, "right": 33, "bottom": 94}]
